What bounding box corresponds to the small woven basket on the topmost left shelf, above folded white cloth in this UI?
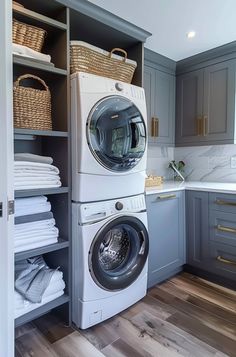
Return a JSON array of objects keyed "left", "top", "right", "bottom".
[{"left": 12, "top": 19, "right": 46, "bottom": 52}]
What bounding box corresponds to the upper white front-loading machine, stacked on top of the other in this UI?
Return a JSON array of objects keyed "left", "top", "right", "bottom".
[{"left": 71, "top": 72, "right": 147, "bottom": 202}]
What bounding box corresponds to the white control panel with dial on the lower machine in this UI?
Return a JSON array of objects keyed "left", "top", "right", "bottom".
[{"left": 79, "top": 195, "right": 146, "bottom": 224}]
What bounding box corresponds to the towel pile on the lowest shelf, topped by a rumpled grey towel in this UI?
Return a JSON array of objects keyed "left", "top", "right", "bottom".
[{"left": 15, "top": 256, "right": 65, "bottom": 318}]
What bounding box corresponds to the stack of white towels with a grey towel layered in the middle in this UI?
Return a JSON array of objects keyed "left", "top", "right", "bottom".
[{"left": 14, "top": 196, "right": 59, "bottom": 253}]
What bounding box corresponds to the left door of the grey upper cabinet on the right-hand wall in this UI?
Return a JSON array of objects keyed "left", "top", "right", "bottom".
[{"left": 176, "top": 70, "right": 204, "bottom": 145}]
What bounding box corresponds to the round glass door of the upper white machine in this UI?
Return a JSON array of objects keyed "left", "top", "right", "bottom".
[{"left": 87, "top": 96, "right": 146, "bottom": 171}]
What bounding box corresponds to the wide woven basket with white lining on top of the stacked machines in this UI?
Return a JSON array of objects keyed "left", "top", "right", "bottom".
[{"left": 70, "top": 41, "right": 137, "bottom": 83}]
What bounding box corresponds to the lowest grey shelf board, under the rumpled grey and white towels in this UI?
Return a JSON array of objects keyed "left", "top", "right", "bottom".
[{"left": 15, "top": 295, "right": 70, "bottom": 327}]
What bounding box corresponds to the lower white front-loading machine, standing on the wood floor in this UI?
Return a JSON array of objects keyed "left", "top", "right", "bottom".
[{"left": 72, "top": 195, "right": 149, "bottom": 329}]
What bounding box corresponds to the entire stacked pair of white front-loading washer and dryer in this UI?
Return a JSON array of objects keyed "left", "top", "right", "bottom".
[{"left": 71, "top": 72, "right": 149, "bottom": 329}]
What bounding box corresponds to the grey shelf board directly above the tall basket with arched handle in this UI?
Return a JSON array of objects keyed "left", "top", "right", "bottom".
[{"left": 13, "top": 54, "right": 67, "bottom": 76}]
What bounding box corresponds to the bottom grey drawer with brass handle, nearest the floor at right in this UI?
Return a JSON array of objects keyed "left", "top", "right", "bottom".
[{"left": 208, "top": 243, "right": 236, "bottom": 281}]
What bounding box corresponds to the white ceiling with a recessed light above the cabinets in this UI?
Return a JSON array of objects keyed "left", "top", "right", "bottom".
[{"left": 87, "top": 0, "right": 236, "bottom": 61}]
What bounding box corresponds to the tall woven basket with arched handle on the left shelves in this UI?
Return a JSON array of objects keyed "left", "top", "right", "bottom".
[{"left": 13, "top": 74, "right": 52, "bottom": 130}]
